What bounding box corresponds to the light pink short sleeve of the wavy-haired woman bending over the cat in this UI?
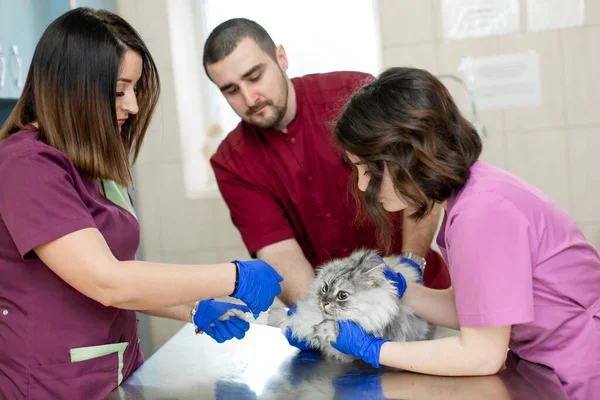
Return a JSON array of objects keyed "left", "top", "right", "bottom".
[{"left": 446, "top": 193, "right": 535, "bottom": 327}]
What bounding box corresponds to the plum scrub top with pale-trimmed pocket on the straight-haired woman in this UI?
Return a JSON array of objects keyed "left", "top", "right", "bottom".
[{"left": 0, "top": 125, "right": 143, "bottom": 399}]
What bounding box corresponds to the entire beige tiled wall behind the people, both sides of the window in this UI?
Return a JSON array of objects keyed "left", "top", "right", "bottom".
[{"left": 118, "top": 0, "right": 600, "bottom": 355}]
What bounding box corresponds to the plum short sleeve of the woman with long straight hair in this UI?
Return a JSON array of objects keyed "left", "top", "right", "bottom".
[{"left": 0, "top": 151, "right": 95, "bottom": 258}]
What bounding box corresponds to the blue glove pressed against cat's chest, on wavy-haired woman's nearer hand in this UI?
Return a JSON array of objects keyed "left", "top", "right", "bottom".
[{"left": 331, "top": 321, "right": 389, "bottom": 368}]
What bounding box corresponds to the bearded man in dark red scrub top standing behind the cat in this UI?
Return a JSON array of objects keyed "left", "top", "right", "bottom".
[{"left": 203, "top": 18, "right": 450, "bottom": 305}]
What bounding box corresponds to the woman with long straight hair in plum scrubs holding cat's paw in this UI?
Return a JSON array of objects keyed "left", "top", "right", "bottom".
[{"left": 0, "top": 8, "right": 282, "bottom": 399}]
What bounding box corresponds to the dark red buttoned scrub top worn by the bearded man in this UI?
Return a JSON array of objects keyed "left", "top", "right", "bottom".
[{"left": 211, "top": 72, "right": 450, "bottom": 288}]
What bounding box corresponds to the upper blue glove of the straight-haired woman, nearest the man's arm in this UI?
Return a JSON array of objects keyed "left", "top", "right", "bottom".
[{"left": 231, "top": 260, "right": 283, "bottom": 314}]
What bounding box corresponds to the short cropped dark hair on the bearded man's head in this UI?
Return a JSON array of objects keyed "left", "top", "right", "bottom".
[{"left": 202, "top": 18, "right": 277, "bottom": 78}]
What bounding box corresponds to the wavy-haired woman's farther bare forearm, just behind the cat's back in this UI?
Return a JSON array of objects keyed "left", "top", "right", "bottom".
[{"left": 402, "top": 282, "right": 460, "bottom": 329}]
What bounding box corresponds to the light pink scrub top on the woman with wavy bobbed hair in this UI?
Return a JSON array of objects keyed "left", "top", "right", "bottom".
[{"left": 437, "top": 161, "right": 600, "bottom": 399}]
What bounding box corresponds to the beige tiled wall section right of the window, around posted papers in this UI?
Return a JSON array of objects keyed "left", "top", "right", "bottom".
[{"left": 379, "top": 0, "right": 600, "bottom": 247}]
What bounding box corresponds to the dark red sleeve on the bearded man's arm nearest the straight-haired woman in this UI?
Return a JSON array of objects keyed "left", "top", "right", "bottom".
[{"left": 211, "top": 156, "right": 295, "bottom": 255}]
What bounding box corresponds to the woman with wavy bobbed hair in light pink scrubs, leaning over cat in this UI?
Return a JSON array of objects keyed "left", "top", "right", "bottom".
[{"left": 333, "top": 68, "right": 600, "bottom": 399}]
